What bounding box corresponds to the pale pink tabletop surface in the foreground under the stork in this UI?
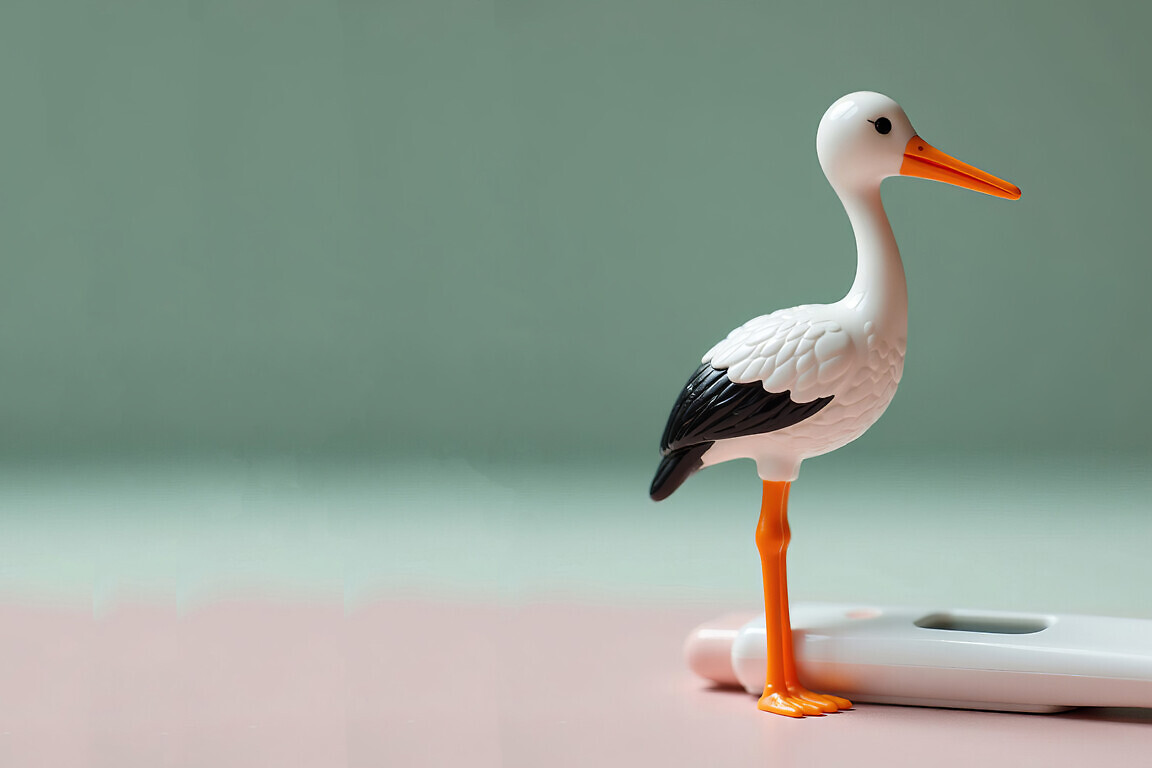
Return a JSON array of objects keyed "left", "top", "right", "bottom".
[{"left": 0, "top": 600, "right": 1152, "bottom": 768}]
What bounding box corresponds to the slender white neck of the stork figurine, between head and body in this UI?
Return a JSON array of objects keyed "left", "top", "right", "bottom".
[{"left": 836, "top": 184, "right": 908, "bottom": 337}]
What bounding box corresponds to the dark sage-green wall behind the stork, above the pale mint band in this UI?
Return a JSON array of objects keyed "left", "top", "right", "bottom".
[{"left": 0, "top": 0, "right": 1152, "bottom": 461}]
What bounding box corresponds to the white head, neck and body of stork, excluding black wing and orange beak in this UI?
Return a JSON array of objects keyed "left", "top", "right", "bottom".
[{"left": 702, "top": 92, "right": 915, "bottom": 481}]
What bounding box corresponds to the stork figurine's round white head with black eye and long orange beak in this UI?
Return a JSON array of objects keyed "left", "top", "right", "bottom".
[{"left": 816, "top": 91, "right": 1020, "bottom": 200}]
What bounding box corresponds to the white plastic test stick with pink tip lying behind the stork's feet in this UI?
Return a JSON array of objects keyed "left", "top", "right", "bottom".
[{"left": 684, "top": 603, "right": 1152, "bottom": 713}]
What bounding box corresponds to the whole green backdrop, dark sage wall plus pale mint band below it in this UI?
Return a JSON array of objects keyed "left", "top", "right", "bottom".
[{"left": 0, "top": 0, "right": 1152, "bottom": 621}]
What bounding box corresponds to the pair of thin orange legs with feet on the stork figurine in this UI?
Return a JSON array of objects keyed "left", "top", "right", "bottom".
[{"left": 756, "top": 480, "right": 852, "bottom": 717}]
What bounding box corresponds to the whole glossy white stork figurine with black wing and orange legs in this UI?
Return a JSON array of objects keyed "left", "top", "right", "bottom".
[{"left": 650, "top": 91, "right": 1020, "bottom": 717}]
